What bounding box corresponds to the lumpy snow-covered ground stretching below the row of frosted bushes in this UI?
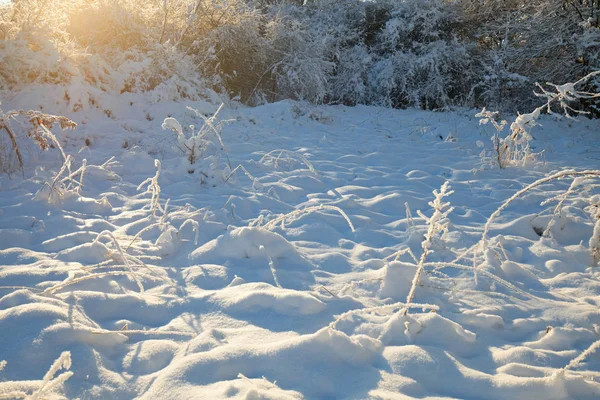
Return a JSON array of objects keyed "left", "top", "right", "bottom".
[{"left": 0, "top": 88, "right": 600, "bottom": 399}]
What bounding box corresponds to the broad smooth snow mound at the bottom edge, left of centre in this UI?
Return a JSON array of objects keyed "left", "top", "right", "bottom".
[{"left": 142, "top": 328, "right": 382, "bottom": 399}]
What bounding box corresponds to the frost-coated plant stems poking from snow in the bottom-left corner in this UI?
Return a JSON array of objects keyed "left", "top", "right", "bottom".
[{"left": 0, "top": 351, "right": 73, "bottom": 400}]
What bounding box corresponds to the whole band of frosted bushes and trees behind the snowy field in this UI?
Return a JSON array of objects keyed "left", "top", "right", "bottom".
[{"left": 0, "top": 0, "right": 600, "bottom": 113}]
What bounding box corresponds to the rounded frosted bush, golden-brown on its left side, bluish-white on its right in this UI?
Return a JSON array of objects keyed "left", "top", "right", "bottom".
[{"left": 182, "top": 0, "right": 333, "bottom": 104}]
